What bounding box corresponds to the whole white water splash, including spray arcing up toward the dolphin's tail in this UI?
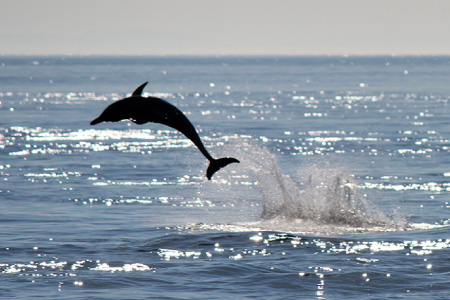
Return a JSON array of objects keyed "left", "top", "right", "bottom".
[{"left": 210, "top": 139, "right": 406, "bottom": 231}]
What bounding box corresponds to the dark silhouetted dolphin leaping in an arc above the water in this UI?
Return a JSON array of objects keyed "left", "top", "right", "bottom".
[{"left": 91, "top": 82, "right": 239, "bottom": 180}]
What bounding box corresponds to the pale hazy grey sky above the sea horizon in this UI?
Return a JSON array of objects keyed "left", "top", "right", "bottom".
[{"left": 0, "top": 0, "right": 450, "bottom": 55}]
